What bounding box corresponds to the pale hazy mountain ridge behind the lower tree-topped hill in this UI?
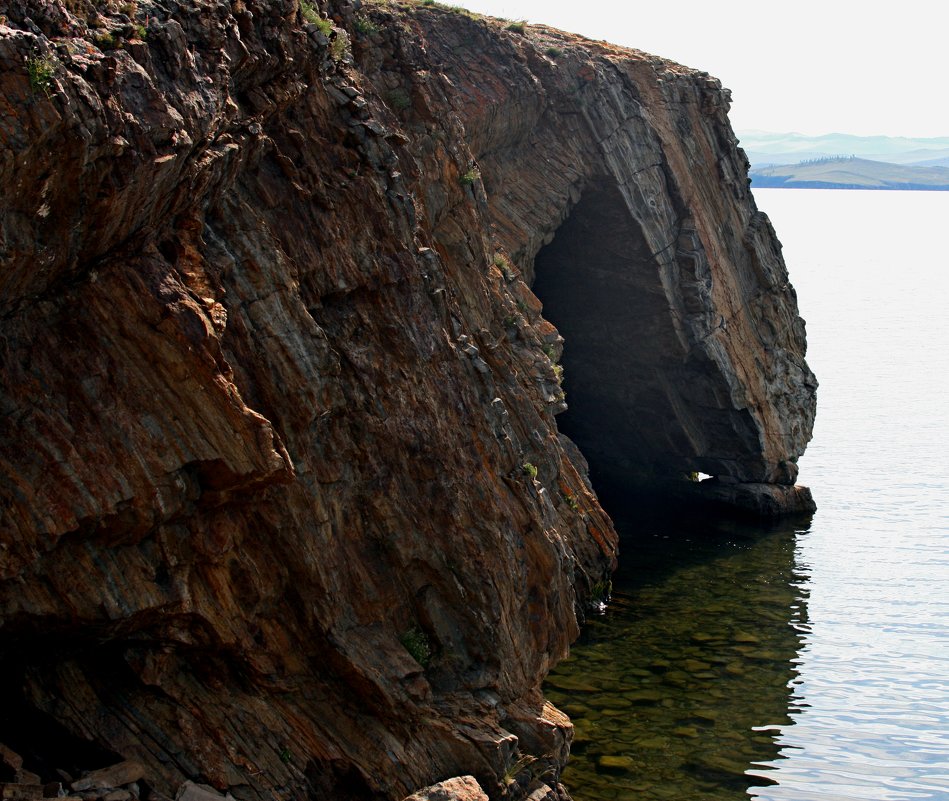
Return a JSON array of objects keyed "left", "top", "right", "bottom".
[{"left": 738, "top": 131, "right": 949, "bottom": 168}]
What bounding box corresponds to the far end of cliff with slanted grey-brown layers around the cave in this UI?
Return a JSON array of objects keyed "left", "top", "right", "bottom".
[{"left": 430, "top": 28, "right": 817, "bottom": 514}]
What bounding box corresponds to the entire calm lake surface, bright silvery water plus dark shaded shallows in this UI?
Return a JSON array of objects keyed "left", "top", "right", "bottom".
[{"left": 546, "top": 189, "right": 949, "bottom": 801}]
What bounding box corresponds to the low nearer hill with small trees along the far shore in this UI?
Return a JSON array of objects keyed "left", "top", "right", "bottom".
[{"left": 749, "top": 157, "right": 949, "bottom": 191}]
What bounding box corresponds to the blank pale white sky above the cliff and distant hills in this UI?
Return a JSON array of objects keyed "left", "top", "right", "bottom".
[{"left": 444, "top": 0, "right": 949, "bottom": 136}]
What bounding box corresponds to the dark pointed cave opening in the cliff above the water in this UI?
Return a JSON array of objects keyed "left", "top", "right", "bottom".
[{"left": 533, "top": 182, "right": 700, "bottom": 504}]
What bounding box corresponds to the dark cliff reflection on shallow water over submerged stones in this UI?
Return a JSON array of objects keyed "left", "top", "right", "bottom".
[{"left": 545, "top": 510, "right": 807, "bottom": 801}]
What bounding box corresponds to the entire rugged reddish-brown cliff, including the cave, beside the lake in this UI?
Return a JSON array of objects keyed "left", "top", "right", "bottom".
[{"left": 0, "top": 0, "right": 815, "bottom": 799}]
